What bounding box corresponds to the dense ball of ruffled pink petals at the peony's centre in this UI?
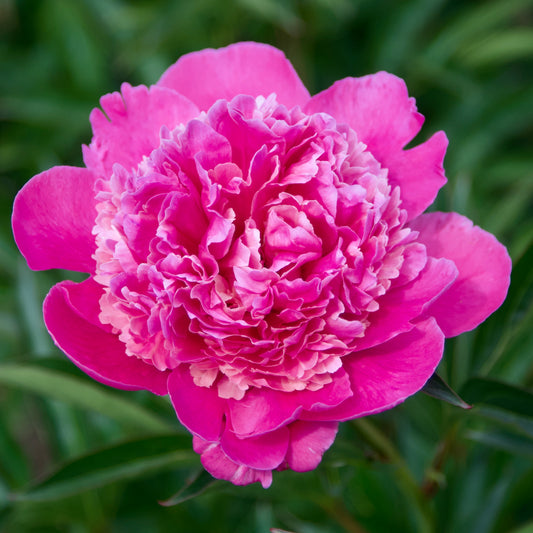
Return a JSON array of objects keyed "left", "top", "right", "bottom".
[{"left": 94, "top": 95, "right": 412, "bottom": 399}]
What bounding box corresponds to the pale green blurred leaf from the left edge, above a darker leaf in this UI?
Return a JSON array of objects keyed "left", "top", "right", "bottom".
[{"left": 0, "top": 364, "right": 172, "bottom": 433}]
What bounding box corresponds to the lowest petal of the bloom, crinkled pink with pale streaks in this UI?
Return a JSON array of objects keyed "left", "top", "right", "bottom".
[{"left": 192, "top": 436, "right": 272, "bottom": 489}]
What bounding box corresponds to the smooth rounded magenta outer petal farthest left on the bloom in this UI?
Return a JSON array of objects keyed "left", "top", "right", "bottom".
[{"left": 12, "top": 167, "right": 96, "bottom": 273}]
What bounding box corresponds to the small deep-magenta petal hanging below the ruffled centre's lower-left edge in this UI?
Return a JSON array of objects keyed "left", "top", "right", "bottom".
[{"left": 168, "top": 365, "right": 225, "bottom": 441}]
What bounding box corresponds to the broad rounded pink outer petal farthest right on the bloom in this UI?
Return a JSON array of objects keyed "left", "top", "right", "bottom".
[{"left": 411, "top": 213, "right": 511, "bottom": 337}]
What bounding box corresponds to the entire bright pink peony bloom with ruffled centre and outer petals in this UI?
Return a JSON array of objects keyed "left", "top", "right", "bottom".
[{"left": 13, "top": 43, "right": 510, "bottom": 487}]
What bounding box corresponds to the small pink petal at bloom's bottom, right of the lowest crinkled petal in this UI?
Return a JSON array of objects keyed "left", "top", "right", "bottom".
[{"left": 287, "top": 420, "right": 339, "bottom": 472}]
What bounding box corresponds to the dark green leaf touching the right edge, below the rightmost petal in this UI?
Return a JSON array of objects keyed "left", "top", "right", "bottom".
[{"left": 461, "top": 378, "right": 533, "bottom": 417}]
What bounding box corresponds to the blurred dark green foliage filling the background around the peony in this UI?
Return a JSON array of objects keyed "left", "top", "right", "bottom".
[{"left": 0, "top": 0, "right": 533, "bottom": 533}]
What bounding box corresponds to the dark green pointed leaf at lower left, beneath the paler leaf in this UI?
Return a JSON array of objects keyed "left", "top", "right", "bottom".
[{"left": 10, "top": 435, "right": 198, "bottom": 502}]
